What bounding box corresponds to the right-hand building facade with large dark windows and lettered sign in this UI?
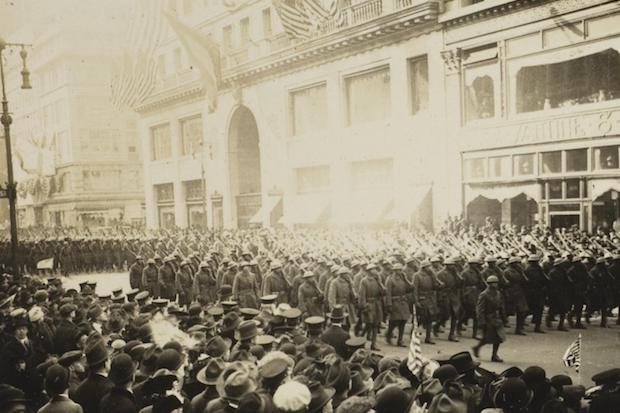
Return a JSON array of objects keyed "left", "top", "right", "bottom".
[{"left": 439, "top": 0, "right": 620, "bottom": 231}]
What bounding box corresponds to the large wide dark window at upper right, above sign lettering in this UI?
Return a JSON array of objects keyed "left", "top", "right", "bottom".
[{"left": 516, "top": 48, "right": 620, "bottom": 113}]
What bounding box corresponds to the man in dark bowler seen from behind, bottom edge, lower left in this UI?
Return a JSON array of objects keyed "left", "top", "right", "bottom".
[{"left": 99, "top": 353, "right": 138, "bottom": 413}]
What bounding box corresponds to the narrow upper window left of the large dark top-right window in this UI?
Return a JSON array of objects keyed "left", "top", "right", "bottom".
[{"left": 465, "top": 62, "right": 497, "bottom": 121}]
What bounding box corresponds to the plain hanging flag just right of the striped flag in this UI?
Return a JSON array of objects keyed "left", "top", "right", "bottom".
[{"left": 165, "top": 13, "right": 220, "bottom": 112}]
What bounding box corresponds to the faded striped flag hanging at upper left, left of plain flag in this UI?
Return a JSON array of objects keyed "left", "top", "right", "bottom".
[{"left": 111, "top": 0, "right": 166, "bottom": 109}]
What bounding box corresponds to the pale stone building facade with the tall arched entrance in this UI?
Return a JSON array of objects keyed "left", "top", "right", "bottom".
[{"left": 138, "top": 0, "right": 452, "bottom": 228}]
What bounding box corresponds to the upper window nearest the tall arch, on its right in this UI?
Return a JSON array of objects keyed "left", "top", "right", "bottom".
[{"left": 290, "top": 83, "right": 327, "bottom": 135}]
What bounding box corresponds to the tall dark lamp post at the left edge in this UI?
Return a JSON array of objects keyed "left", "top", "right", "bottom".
[{"left": 0, "top": 37, "right": 32, "bottom": 274}]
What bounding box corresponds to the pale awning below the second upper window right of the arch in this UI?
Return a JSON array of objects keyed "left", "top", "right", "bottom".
[{"left": 337, "top": 193, "right": 394, "bottom": 224}]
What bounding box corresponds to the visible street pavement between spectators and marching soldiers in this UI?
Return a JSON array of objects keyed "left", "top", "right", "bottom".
[{"left": 63, "top": 272, "right": 620, "bottom": 386}]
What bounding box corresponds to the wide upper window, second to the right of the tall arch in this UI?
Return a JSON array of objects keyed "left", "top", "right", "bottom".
[{"left": 345, "top": 66, "right": 391, "bottom": 125}]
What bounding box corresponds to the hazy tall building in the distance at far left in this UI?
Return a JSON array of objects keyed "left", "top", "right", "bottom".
[{"left": 3, "top": 0, "right": 144, "bottom": 228}]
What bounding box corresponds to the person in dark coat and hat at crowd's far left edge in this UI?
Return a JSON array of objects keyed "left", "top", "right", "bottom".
[{"left": 0, "top": 310, "right": 36, "bottom": 398}]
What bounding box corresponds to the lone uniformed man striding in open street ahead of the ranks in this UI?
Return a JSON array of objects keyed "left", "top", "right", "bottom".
[{"left": 473, "top": 275, "right": 506, "bottom": 363}]
